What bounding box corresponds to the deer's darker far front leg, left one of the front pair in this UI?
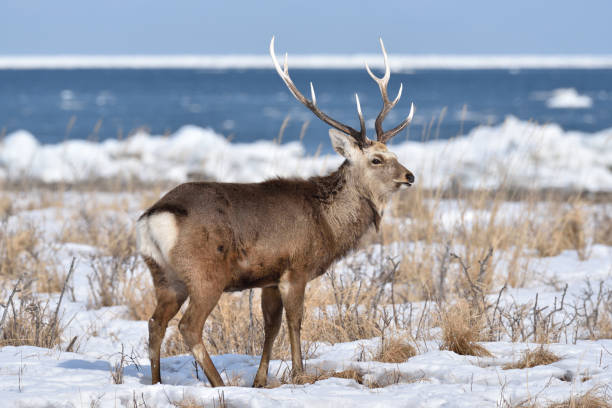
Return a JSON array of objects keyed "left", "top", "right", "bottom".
[{"left": 253, "top": 287, "right": 283, "bottom": 388}]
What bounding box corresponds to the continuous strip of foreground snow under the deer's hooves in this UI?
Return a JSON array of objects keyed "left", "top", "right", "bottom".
[{"left": 0, "top": 340, "right": 612, "bottom": 408}]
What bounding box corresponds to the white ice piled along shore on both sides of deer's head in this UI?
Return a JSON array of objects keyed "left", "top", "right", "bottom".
[{"left": 0, "top": 117, "right": 612, "bottom": 191}]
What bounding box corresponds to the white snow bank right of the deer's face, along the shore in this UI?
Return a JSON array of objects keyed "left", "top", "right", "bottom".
[{"left": 393, "top": 117, "right": 612, "bottom": 191}]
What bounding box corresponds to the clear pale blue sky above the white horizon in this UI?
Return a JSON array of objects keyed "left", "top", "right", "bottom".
[{"left": 0, "top": 0, "right": 612, "bottom": 55}]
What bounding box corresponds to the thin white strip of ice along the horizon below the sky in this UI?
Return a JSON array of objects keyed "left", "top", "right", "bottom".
[{"left": 0, "top": 54, "right": 612, "bottom": 71}]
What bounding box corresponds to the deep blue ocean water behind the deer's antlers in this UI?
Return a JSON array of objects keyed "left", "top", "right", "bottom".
[{"left": 0, "top": 69, "right": 612, "bottom": 153}]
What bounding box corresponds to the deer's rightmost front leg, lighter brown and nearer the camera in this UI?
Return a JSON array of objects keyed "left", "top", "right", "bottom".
[{"left": 279, "top": 280, "right": 306, "bottom": 378}]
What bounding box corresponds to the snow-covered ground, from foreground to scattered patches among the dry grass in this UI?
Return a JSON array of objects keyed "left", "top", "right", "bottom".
[{"left": 0, "top": 191, "right": 612, "bottom": 408}]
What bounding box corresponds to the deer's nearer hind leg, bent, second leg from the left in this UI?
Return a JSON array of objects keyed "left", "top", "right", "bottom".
[{"left": 179, "top": 288, "right": 224, "bottom": 387}]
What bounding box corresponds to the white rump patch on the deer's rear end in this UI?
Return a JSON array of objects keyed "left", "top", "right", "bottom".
[{"left": 136, "top": 212, "right": 178, "bottom": 265}]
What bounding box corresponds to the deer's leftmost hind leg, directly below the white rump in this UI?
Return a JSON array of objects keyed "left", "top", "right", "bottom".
[{"left": 145, "top": 257, "right": 187, "bottom": 384}]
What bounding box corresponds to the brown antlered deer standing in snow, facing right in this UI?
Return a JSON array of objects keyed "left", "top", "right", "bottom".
[{"left": 136, "top": 37, "right": 415, "bottom": 387}]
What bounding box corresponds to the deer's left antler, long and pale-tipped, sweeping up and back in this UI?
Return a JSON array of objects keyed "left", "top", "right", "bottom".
[{"left": 270, "top": 37, "right": 367, "bottom": 146}]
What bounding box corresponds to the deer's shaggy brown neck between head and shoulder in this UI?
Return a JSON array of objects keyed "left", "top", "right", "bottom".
[{"left": 313, "top": 161, "right": 384, "bottom": 254}]
